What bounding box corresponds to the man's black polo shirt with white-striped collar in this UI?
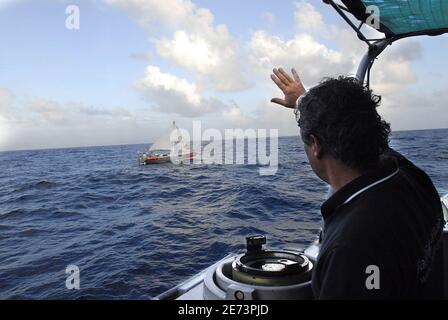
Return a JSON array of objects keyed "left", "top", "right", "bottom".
[{"left": 312, "top": 150, "right": 444, "bottom": 299}]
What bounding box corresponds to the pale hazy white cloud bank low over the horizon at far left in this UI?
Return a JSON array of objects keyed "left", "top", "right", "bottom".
[{"left": 0, "top": 89, "right": 166, "bottom": 150}]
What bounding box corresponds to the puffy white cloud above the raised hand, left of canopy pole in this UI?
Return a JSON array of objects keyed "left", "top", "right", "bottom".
[{"left": 248, "top": 1, "right": 363, "bottom": 85}]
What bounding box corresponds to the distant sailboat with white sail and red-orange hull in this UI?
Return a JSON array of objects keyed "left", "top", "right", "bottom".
[{"left": 139, "top": 121, "right": 195, "bottom": 165}]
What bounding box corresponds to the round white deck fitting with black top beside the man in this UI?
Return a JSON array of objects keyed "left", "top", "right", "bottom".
[{"left": 204, "top": 236, "right": 313, "bottom": 300}]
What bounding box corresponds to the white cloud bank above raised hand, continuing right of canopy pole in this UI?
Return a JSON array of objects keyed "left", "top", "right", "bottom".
[{"left": 248, "top": 1, "right": 421, "bottom": 94}]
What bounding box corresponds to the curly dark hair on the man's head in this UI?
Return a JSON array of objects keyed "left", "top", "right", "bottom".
[{"left": 298, "top": 76, "right": 391, "bottom": 170}]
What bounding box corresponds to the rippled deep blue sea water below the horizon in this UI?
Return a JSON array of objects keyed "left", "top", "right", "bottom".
[{"left": 0, "top": 130, "right": 448, "bottom": 299}]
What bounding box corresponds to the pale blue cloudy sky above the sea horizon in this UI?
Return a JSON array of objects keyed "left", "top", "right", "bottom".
[{"left": 0, "top": 0, "right": 448, "bottom": 151}]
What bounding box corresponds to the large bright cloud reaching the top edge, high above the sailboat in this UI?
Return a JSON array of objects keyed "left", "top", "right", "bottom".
[{"left": 106, "top": 0, "right": 248, "bottom": 91}]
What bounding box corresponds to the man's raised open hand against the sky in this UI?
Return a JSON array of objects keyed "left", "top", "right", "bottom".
[{"left": 271, "top": 68, "right": 306, "bottom": 109}]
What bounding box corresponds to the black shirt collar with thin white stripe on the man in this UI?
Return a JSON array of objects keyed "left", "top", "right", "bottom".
[{"left": 321, "top": 159, "right": 399, "bottom": 220}]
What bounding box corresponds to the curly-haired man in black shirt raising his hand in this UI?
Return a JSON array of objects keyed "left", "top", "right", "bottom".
[{"left": 271, "top": 69, "right": 444, "bottom": 299}]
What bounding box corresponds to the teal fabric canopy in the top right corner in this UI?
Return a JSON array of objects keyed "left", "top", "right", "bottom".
[{"left": 343, "top": 0, "right": 448, "bottom": 36}]
